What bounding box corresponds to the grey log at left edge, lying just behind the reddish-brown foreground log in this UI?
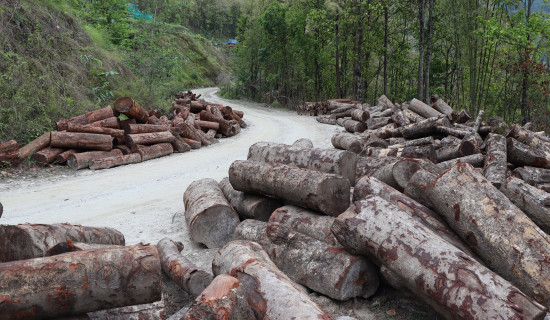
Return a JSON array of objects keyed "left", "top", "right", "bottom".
[{"left": 0, "top": 223, "right": 124, "bottom": 262}]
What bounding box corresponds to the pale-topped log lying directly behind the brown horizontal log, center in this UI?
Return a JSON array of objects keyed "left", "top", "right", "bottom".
[{"left": 248, "top": 142, "right": 357, "bottom": 184}]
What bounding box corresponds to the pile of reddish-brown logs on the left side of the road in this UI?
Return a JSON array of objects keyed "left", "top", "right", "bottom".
[{"left": 0, "top": 91, "right": 246, "bottom": 170}]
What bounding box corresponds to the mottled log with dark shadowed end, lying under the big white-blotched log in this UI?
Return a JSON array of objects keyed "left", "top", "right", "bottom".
[{"left": 235, "top": 220, "right": 379, "bottom": 300}]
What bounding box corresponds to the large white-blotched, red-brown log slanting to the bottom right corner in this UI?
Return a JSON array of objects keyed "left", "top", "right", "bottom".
[{"left": 332, "top": 196, "right": 546, "bottom": 319}]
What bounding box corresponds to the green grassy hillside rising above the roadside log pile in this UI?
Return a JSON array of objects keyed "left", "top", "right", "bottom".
[{"left": 0, "top": 0, "right": 228, "bottom": 144}]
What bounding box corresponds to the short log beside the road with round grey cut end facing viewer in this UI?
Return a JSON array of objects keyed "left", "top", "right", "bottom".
[{"left": 183, "top": 178, "right": 239, "bottom": 248}]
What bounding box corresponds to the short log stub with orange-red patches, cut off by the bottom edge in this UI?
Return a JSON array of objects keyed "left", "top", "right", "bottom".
[{"left": 181, "top": 274, "right": 256, "bottom": 320}]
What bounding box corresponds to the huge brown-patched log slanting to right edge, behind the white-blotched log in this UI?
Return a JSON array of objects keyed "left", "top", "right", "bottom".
[{"left": 411, "top": 164, "right": 550, "bottom": 306}]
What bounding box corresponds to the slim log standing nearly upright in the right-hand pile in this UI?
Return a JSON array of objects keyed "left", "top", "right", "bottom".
[{"left": 483, "top": 133, "right": 507, "bottom": 188}]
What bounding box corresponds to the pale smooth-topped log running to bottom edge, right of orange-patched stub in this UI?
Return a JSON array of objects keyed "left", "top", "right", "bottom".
[{"left": 212, "top": 241, "right": 332, "bottom": 320}]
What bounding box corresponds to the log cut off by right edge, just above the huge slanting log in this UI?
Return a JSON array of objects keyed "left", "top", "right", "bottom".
[{"left": 500, "top": 177, "right": 550, "bottom": 234}]
